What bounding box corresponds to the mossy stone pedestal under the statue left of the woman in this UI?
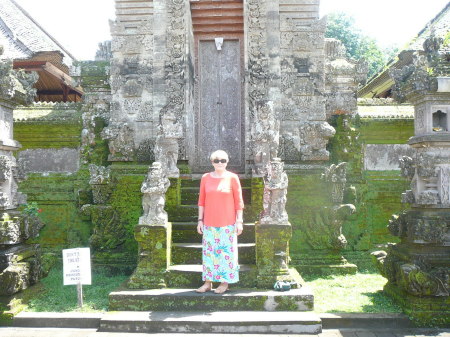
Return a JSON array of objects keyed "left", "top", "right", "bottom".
[{"left": 128, "top": 222, "right": 172, "bottom": 289}]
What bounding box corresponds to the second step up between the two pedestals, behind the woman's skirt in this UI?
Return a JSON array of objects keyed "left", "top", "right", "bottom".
[{"left": 172, "top": 243, "right": 256, "bottom": 264}]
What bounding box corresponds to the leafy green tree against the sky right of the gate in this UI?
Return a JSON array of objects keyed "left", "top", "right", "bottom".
[{"left": 325, "top": 12, "right": 397, "bottom": 78}]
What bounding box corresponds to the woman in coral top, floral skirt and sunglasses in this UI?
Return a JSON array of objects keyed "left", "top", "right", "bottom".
[{"left": 196, "top": 150, "right": 244, "bottom": 294}]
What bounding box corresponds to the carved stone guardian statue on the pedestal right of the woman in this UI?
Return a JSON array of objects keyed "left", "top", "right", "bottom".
[{"left": 260, "top": 158, "right": 288, "bottom": 225}]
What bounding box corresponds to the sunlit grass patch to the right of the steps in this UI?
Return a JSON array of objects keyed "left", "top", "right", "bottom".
[{"left": 304, "top": 273, "right": 402, "bottom": 313}]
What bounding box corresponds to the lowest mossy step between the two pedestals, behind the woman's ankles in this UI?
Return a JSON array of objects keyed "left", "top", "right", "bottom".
[{"left": 165, "top": 264, "right": 257, "bottom": 288}]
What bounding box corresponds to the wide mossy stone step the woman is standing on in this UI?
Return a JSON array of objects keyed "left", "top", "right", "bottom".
[{"left": 109, "top": 286, "right": 314, "bottom": 313}]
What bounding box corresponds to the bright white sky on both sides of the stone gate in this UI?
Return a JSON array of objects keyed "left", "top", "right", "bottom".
[{"left": 15, "top": 0, "right": 448, "bottom": 60}]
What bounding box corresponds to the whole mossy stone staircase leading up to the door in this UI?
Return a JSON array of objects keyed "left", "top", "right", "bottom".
[{"left": 108, "top": 175, "right": 322, "bottom": 333}]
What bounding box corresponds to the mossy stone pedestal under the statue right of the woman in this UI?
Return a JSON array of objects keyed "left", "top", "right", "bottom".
[{"left": 255, "top": 222, "right": 301, "bottom": 289}]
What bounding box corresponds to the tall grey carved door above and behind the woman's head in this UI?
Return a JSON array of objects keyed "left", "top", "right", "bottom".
[{"left": 194, "top": 40, "right": 244, "bottom": 172}]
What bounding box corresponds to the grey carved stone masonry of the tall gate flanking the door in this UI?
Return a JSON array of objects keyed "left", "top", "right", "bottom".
[{"left": 103, "top": 0, "right": 364, "bottom": 169}]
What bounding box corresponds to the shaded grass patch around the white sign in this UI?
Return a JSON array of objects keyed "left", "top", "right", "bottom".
[{"left": 26, "top": 267, "right": 128, "bottom": 312}]
